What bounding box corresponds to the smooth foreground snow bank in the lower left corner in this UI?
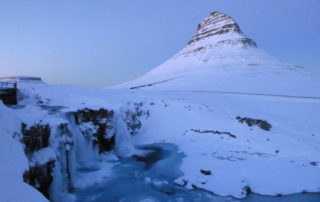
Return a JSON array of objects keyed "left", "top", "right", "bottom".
[{"left": 0, "top": 101, "right": 47, "bottom": 202}]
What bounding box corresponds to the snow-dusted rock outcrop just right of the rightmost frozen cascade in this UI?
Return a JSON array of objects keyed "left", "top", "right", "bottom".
[{"left": 125, "top": 102, "right": 150, "bottom": 135}]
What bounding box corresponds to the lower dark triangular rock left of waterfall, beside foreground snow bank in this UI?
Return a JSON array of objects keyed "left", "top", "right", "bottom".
[{"left": 23, "top": 161, "right": 55, "bottom": 199}]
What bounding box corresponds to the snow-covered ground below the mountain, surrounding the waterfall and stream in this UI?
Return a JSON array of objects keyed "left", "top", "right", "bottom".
[{"left": 0, "top": 81, "right": 320, "bottom": 201}]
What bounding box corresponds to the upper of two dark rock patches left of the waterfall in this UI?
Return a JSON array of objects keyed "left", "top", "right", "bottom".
[{"left": 21, "top": 123, "right": 51, "bottom": 154}]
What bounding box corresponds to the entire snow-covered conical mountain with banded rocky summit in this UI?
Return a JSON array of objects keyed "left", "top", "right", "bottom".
[{"left": 118, "top": 12, "right": 320, "bottom": 96}]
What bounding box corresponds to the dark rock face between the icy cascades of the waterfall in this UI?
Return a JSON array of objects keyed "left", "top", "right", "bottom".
[{"left": 75, "top": 108, "right": 115, "bottom": 153}]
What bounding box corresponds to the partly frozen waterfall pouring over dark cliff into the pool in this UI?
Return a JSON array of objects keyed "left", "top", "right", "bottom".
[{"left": 22, "top": 109, "right": 135, "bottom": 202}]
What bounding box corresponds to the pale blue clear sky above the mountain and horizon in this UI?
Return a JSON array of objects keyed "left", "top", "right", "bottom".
[{"left": 0, "top": 0, "right": 320, "bottom": 86}]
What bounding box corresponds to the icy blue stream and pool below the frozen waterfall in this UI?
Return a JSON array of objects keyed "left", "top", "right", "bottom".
[{"left": 74, "top": 143, "right": 320, "bottom": 202}]
